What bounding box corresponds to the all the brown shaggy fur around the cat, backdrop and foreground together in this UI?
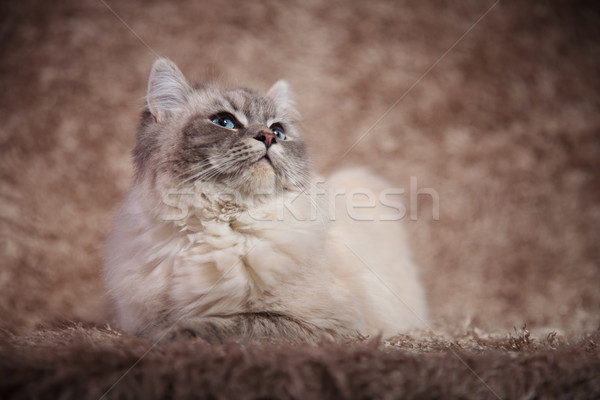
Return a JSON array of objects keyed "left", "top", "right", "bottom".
[{"left": 0, "top": 0, "right": 600, "bottom": 398}]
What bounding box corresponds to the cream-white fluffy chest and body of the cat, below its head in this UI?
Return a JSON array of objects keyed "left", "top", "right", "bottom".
[{"left": 105, "top": 169, "right": 426, "bottom": 335}]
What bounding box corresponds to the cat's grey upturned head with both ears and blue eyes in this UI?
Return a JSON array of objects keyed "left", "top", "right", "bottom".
[{"left": 134, "top": 58, "right": 311, "bottom": 203}]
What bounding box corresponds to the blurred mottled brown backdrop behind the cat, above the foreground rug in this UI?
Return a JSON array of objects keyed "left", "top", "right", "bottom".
[{"left": 0, "top": 0, "right": 600, "bottom": 333}]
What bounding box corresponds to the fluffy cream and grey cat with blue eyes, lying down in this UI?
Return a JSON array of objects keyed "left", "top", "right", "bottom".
[{"left": 104, "top": 58, "right": 427, "bottom": 343}]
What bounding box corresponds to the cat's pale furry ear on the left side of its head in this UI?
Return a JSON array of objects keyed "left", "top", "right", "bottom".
[{"left": 146, "top": 57, "right": 192, "bottom": 122}]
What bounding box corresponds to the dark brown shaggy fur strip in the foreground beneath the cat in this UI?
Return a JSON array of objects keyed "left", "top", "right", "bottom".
[{"left": 0, "top": 328, "right": 600, "bottom": 399}]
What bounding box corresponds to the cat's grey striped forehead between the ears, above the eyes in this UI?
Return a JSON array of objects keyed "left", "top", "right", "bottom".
[{"left": 199, "top": 86, "right": 283, "bottom": 123}]
